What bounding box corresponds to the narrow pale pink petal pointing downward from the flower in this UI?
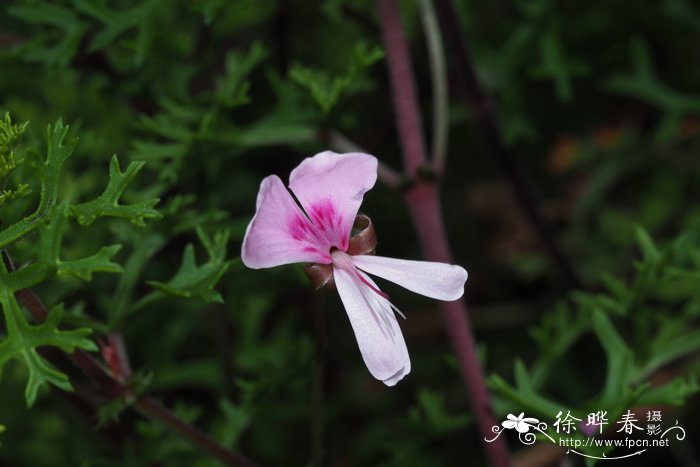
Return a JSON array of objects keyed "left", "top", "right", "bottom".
[{"left": 333, "top": 268, "right": 411, "bottom": 386}]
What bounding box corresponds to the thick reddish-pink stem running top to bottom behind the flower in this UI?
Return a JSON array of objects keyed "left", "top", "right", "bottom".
[{"left": 377, "top": 0, "right": 510, "bottom": 467}]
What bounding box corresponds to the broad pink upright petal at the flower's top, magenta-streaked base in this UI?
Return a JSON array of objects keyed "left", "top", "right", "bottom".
[{"left": 289, "top": 151, "right": 377, "bottom": 251}]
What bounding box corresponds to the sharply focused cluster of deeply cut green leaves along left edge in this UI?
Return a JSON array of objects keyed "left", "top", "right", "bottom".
[{"left": 0, "top": 115, "right": 155, "bottom": 406}]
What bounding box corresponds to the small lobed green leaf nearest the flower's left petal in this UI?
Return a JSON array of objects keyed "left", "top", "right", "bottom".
[{"left": 148, "top": 228, "right": 231, "bottom": 303}]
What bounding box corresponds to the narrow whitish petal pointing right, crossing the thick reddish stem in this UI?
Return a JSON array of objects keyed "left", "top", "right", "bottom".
[{"left": 352, "top": 255, "right": 467, "bottom": 300}]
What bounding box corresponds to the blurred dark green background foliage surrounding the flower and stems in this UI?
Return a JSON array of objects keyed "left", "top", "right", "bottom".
[{"left": 0, "top": 0, "right": 700, "bottom": 466}]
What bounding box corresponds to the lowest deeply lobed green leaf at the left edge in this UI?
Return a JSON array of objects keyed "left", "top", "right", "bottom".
[{"left": 0, "top": 294, "right": 97, "bottom": 407}]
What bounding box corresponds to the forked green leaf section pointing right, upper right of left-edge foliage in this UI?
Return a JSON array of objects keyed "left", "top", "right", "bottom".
[{"left": 71, "top": 155, "right": 161, "bottom": 227}]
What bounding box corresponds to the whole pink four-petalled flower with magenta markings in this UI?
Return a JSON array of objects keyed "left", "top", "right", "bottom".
[{"left": 241, "top": 151, "right": 467, "bottom": 386}]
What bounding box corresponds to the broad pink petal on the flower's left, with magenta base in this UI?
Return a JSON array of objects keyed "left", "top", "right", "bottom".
[{"left": 241, "top": 175, "right": 331, "bottom": 269}]
